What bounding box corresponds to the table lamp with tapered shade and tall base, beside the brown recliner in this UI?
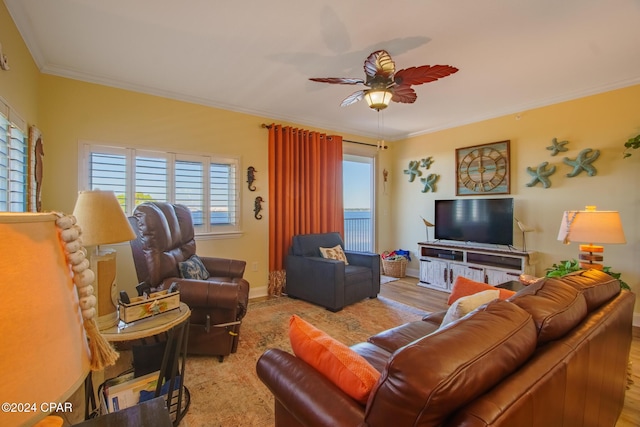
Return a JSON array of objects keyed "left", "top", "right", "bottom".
[{"left": 73, "top": 190, "right": 136, "bottom": 330}]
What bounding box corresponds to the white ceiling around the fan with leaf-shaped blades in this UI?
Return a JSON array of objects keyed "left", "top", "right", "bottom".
[{"left": 4, "top": 0, "right": 640, "bottom": 140}]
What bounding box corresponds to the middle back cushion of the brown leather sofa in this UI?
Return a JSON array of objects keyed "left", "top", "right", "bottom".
[{"left": 509, "top": 278, "right": 587, "bottom": 345}]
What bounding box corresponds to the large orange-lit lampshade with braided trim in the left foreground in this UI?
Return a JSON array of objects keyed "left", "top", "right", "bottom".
[{"left": 0, "top": 212, "right": 90, "bottom": 426}]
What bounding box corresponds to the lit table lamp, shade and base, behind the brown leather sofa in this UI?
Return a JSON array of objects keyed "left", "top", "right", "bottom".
[{"left": 558, "top": 206, "right": 627, "bottom": 270}]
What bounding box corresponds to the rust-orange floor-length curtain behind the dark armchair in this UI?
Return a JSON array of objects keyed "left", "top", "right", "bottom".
[{"left": 268, "top": 125, "right": 344, "bottom": 295}]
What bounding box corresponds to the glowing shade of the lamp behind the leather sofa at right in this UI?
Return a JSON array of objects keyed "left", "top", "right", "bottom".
[{"left": 558, "top": 207, "right": 627, "bottom": 244}]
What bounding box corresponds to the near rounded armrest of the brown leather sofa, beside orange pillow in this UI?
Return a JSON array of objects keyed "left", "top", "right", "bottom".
[{"left": 256, "top": 349, "right": 365, "bottom": 427}]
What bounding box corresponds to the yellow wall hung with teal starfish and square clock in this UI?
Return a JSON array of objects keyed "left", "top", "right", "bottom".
[{"left": 381, "top": 85, "right": 640, "bottom": 312}]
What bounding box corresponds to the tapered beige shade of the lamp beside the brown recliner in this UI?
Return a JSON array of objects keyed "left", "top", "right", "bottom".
[{"left": 73, "top": 190, "right": 136, "bottom": 246}]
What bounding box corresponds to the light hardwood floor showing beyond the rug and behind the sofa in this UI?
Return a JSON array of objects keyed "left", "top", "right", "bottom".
[{"left": 380, "top": 276, "right": 640, "bottom": 427}]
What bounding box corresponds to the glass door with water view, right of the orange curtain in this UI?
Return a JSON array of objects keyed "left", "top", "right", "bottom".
[{"left": 343, "top": 154, "right": 375, "bottom": 252}]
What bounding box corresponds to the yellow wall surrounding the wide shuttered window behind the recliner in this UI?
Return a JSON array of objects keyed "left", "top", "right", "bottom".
[{"left": 39, "top": 75, "right": 376, "bottom": 296}]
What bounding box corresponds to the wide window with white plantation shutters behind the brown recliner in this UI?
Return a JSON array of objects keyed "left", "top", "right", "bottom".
[{"left": 80, "top": 144, "right": 240, "bottom": 234}]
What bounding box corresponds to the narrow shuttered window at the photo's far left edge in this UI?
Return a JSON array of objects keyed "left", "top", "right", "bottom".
[{"left": 0, "top": 101, "right": 28, "bottom": 212}]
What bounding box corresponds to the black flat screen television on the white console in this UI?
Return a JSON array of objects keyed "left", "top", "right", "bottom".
[{"left": 435, "top": 198, "right": 513, "bottom": 245}]
